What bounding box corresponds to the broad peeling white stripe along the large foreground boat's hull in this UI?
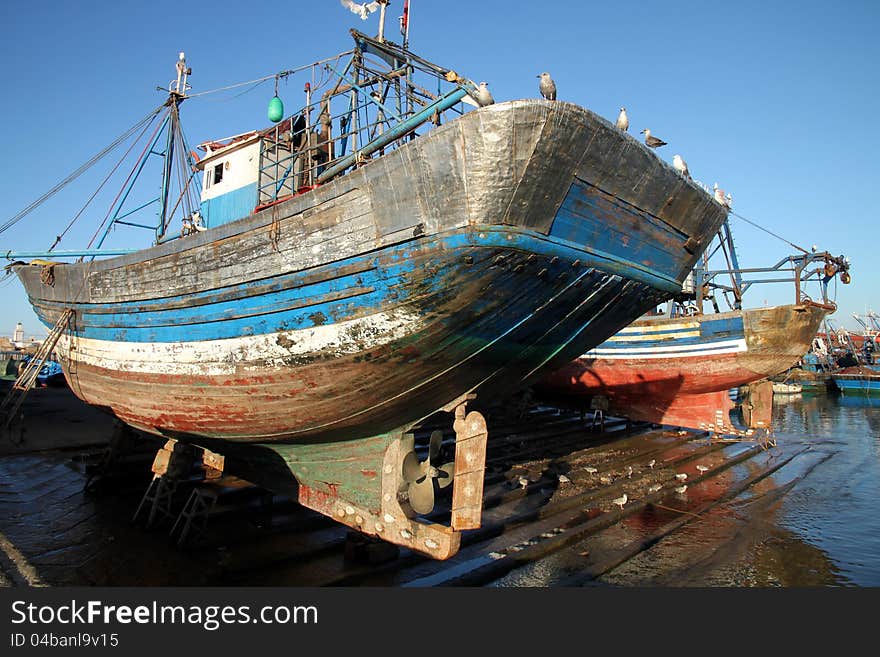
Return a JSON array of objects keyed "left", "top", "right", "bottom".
[{"left": 57, "top": 309, "right": 422, "bottom": 376}]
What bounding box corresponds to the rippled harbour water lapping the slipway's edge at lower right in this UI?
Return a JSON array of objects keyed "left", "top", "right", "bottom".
[{"left": 498, "top": 394, "right": 880, "bottom": 586}]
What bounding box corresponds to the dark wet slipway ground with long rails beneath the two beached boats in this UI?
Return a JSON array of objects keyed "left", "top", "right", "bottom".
[{"left": 0, "top": 388, "right": 830, "bottom": 586}]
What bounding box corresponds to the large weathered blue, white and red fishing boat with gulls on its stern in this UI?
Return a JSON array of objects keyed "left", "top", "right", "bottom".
[{"left": 0, "top": 19, "right": 725, "bottom": 558}]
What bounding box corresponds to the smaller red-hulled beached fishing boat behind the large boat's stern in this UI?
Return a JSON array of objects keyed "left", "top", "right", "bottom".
[{"left": 535, "top": 222, "right": 849, "bottom": 435}]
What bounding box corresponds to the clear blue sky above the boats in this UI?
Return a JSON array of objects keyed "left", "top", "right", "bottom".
[{"left": 0, "top": 0, "right": 880, "bottom": 335}]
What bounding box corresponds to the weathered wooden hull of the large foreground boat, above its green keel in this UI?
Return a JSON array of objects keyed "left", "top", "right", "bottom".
[{"left": 16, "top": 101, "right": 724, "bottom": 443}]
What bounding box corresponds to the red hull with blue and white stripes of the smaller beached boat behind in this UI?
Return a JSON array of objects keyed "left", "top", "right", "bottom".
[{"left": 537, "top": 305, "right": 828, "bottom": 430}]
